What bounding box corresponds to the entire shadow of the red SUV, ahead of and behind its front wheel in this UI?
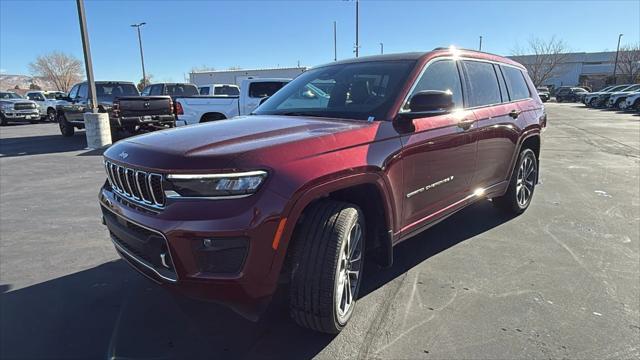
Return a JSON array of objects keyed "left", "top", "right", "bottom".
[{"left": 0, "top": 201, "right": 510, "bottom": 359}]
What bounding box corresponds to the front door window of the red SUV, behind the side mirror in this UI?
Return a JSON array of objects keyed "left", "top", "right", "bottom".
[{"left": 404, "top": 60, "right": 463, "bottom": 110}]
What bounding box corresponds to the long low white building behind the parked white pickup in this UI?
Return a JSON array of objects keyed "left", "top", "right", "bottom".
[{"left": 189, "top": 67, "right": 307, "bottom": 86}]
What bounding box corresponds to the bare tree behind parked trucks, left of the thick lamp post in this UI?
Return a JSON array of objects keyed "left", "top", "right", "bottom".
[{"left": 29, "top": 51, "right": 83, "bottom": 92}]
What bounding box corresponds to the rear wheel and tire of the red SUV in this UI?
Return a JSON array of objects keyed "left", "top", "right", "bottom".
[{"left": 492, "top": 149, "right": 538, "bottom": 215}]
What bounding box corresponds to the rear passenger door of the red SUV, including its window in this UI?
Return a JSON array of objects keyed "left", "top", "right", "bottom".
[{"left": 463, "top": 60, "right": 521, "bottom": 189}]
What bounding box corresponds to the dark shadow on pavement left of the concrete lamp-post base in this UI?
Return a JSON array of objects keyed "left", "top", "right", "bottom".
[{"left": 0, "top": 132, "right": 87, "bottom": 157}]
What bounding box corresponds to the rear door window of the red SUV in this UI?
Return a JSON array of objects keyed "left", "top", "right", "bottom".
[{"left": 464, "top": 61, "right": 502, "bottom": 107}]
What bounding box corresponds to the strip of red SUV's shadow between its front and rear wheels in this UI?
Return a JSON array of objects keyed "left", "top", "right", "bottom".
[{"left": 359, "top": 200, "right": 514, "bottom": 297}]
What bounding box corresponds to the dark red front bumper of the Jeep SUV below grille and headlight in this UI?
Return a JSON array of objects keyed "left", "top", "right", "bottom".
[{"left": 99, "top": 185, "right": 285, "bottom": 306}]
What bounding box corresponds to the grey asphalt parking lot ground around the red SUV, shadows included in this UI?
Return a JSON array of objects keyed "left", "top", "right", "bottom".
[{"left": 0, "top": 103, "right": 640, "bottom": 359}]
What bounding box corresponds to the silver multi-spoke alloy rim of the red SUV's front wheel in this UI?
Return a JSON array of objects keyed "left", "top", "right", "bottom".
[{"left": 334, "top": 222, "right": 363, "bottom": 324}]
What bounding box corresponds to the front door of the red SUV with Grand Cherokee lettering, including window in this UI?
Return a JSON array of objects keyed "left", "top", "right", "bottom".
[{"left": 401, "top": 59, "right": 476, "bottom": 234}]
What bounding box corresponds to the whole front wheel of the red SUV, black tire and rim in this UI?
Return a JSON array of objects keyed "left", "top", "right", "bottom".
[{"left": 289, "top": 200, "right": 365, "bottom": 334}]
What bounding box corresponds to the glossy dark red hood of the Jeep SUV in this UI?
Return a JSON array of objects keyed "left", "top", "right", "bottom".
[{"left": 105, "top": 115, "right": 375, "bottom": 171}]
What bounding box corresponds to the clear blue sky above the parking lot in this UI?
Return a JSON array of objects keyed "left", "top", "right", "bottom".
[{"left": 0, "top": 0, "right": 640, "bottom": 81}]
